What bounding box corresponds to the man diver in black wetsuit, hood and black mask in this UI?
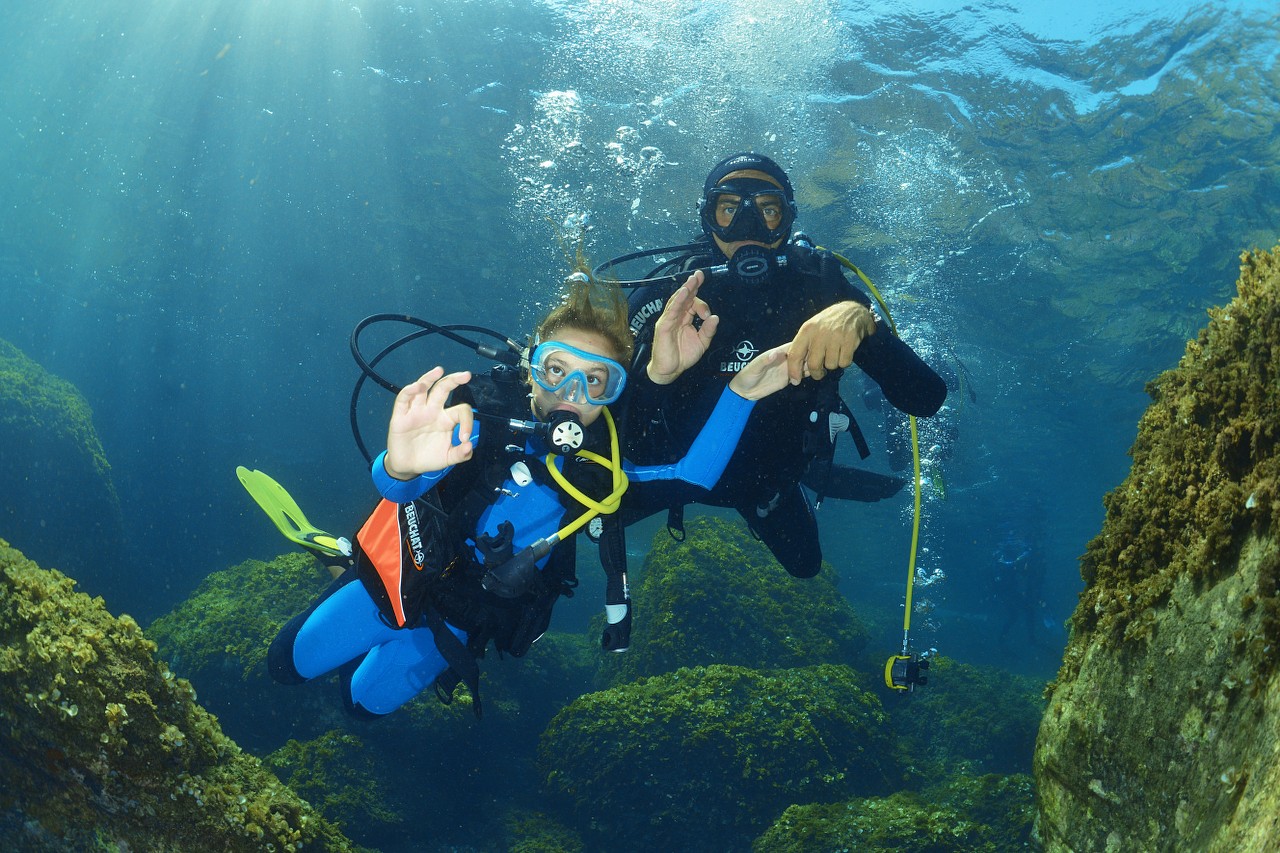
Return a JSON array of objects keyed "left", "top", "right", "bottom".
[{"left": 623, "top": 152, "right": 947, "bottom": 578}]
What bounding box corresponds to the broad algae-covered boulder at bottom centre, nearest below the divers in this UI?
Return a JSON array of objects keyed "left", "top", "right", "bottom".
[{"left": 539, "top": 665, "right": 901, "bottom": 850}]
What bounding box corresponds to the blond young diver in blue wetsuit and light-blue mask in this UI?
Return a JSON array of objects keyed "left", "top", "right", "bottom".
[{"left": 269, "top": 267, "right": 788, "bottom": 717}]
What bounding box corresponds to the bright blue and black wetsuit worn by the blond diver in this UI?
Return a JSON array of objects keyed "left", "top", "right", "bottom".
[{"left": 269, "top": 388, "right": 755, "bottom": 716}]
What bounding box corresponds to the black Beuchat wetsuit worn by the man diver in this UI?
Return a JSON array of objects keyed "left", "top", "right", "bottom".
[{"left": 623, "top": 235, "right": 946, "bottom": 578}]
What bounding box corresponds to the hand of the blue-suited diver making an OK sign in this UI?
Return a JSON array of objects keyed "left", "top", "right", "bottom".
[{"left": 383, "top": 368, "right": 475, "bottom": 480}]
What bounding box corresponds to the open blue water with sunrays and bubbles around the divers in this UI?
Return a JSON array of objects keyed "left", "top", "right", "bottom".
[{"left": 0, "top": 0, "right": 1280, "bottom": 712}]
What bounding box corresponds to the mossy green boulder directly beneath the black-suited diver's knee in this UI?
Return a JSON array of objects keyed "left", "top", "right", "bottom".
[{"left": 602, "top": 516, "right": 868, "bottom": 684}]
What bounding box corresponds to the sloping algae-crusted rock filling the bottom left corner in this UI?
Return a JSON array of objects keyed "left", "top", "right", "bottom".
[{"left": 0, "top": 540, "right": 352, "bottom": 852}]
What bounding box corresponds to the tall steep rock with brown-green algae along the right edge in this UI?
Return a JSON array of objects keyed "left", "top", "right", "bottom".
[{"left": 1034, "top": 247, "right": 1280, "bottom": 853}]
